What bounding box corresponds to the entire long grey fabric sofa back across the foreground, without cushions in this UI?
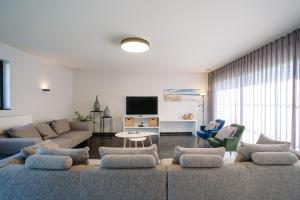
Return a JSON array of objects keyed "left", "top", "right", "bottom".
[{"left": 0, "top": 155, "right": 300, "bottom": 200}]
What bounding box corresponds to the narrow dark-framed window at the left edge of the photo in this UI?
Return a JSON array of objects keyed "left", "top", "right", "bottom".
[{"left": 0, "top": 60, "right": 11, "bottom": 110}]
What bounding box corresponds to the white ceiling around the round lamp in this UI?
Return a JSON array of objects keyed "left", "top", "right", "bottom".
[{"left": 0, "top": 0, "right": 300, "bottom": 72}]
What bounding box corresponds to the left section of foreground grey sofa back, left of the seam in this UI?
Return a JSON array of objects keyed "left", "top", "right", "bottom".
[{"left": 0, "top": 155, "right": 167, "bottom": 200}]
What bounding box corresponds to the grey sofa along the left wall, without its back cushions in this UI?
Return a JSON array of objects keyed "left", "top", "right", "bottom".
[{"left": 0, "top": 122, "right": 93, "bottom": 159}]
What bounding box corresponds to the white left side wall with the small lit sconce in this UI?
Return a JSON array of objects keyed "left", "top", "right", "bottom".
[{"left": 0, "top": 43, "right": 73, "bottom": 122}]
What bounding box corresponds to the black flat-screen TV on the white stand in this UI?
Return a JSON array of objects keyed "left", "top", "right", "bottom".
[{"left": 126, "top": 96, "right": 158, "bottom": 115}]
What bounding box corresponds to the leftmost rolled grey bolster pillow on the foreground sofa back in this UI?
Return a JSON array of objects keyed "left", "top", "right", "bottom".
[{"left": 25, "top": 155, "right": 73, "bottom": 170}]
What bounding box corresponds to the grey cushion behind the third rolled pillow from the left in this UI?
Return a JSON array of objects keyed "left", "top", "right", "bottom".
[{"left": 173, "top": 146, "right": 225, "bottom": 164}]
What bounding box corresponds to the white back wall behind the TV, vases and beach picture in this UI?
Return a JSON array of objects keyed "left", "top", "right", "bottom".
[{"left": 74, "top": 71, "right": 207, "bottom": 131}]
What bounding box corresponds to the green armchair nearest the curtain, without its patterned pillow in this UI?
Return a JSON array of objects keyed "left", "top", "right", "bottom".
[{"left": 208, "top": 124, "right": 245, "bottom": 152}]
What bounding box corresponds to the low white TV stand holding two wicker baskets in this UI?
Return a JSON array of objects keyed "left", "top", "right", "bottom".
[{"left": 123, "top": 115, "right": 160, "bottom": 136}]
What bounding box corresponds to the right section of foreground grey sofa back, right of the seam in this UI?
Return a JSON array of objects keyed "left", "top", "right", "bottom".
[{"left": 167, "top": 161, "right": 300, "bottom": 200}]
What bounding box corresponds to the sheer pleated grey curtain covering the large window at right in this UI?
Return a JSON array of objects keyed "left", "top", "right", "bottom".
[{"left": 208, "top": 29, "right": 300, "bottom": 149}]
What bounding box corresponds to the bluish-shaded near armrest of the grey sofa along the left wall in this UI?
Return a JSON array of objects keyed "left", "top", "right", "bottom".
[{"left": 0, "top": 138, "right": 42, "bottom": 156}]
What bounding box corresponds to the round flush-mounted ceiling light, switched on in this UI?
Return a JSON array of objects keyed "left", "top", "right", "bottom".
[{"left": 121, "top": 37, "right": 150, "bottom": 53}]
